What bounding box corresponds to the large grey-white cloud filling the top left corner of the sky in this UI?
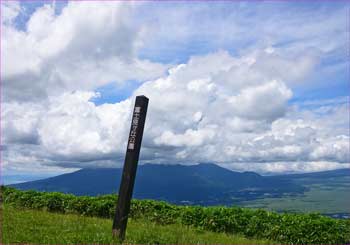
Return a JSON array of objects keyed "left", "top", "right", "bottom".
[{"left": 1, "top": 2, "right": 166, "bottom": 101}]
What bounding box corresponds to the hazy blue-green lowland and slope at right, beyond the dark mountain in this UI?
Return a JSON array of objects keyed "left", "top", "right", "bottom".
[{"left": 240, "top": 169, "right": 350, "bottom": 215}]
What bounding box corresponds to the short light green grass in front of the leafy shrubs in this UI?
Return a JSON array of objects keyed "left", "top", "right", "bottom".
[{"left": 0, "top": 205, "right": 272, "bottom": 244}]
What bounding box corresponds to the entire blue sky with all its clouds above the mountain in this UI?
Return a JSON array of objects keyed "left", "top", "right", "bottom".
[{"left": 1, "top": 1, "right": 350, "bottom": 183}]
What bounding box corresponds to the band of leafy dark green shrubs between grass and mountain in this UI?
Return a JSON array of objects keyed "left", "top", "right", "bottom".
[{"left": 2, "top": 187, "right": 350, "bottom": 244}]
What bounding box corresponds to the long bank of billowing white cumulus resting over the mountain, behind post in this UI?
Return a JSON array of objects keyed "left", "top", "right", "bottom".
[{"left": 4, "top": 51, "right": 349, "bottom": 172}]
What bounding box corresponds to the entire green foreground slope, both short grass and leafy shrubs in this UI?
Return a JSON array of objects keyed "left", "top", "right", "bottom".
[{"left": 1, "top": 187, "right": 350, "bottom": 244}]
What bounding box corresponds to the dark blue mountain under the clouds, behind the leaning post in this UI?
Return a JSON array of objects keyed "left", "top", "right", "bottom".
[{"left": 11, "top": 163, "right": 305, "bottom": 205}]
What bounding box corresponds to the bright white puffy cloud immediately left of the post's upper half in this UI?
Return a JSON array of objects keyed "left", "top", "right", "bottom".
[{"left": 38, "top": 92, "right": 130, "bottom": 161}]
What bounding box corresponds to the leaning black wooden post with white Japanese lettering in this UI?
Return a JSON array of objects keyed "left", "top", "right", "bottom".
[{"left": 112, "top": 95, "right": 148, "bottom": 240}]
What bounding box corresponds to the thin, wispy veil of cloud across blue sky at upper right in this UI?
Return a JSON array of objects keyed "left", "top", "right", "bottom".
[{"left": 137, "top": 2, "right": 349, "bottom": 95}]
